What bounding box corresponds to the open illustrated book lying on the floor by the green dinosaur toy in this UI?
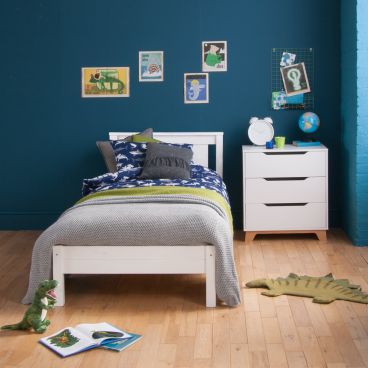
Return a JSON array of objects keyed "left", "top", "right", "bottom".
[{"left": 40, "top": 322, "right": 141, "bottom": 357}]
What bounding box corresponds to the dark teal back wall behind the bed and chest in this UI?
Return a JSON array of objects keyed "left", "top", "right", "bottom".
[{"left": 0, "top": 0, "right": 341, "bottom": 229}]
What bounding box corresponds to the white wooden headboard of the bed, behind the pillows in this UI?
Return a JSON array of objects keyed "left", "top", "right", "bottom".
[{"left": 109, "top": 132, "right": 224, "bottom": 177}]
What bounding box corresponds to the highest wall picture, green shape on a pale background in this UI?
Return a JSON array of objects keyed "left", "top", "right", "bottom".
[{"left": 202, "top": 41, "right": 227, "bottom": 72}]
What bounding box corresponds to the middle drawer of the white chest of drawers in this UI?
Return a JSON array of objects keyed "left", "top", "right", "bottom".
[{"left": 244, "top": 176, "right": 327, "bottom": 203}]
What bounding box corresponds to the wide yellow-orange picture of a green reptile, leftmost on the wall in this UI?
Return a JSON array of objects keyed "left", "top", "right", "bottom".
[{"left": 82, "top": 66, "right": 130, "bottom": 97}]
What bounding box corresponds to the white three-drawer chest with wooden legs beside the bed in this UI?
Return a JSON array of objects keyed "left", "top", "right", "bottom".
[{"left": 242, "top": 145, "right": 328, "bottom": 241}]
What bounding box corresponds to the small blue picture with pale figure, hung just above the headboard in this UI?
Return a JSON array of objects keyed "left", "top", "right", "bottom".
[{"left": 184, "top": 73, "right": 209, "bottom": 103}]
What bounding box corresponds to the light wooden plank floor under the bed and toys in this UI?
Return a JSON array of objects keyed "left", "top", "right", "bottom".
[{"left": 0, "top": 231, "right": 368, "bottom": 368}]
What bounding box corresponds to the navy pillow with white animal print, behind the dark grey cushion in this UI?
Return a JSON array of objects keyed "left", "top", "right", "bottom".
[{"left": 111, "top": 141, "right": 193, "bottom": 178}]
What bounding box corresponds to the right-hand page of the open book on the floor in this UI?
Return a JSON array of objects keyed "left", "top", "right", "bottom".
[{"left": 75, "top": 322, "right": 130, "bottom": 345}]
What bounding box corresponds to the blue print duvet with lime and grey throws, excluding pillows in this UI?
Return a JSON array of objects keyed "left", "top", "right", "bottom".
[{"left": 22, "top": 165, "right": 240, "bottom": 306}]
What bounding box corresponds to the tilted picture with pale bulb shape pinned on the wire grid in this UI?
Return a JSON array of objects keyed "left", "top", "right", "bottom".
[{"left": 280, "top": 63, "right": 311, "bottom": 96}]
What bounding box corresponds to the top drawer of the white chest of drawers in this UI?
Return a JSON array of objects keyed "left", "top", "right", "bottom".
[{"left": 243, "top": 151, "right": 327, "bottom": 178}]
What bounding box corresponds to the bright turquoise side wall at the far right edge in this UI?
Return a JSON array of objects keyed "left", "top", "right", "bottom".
[{"left": 341, "top": 0, "right": 368, "bottom": 245}]
